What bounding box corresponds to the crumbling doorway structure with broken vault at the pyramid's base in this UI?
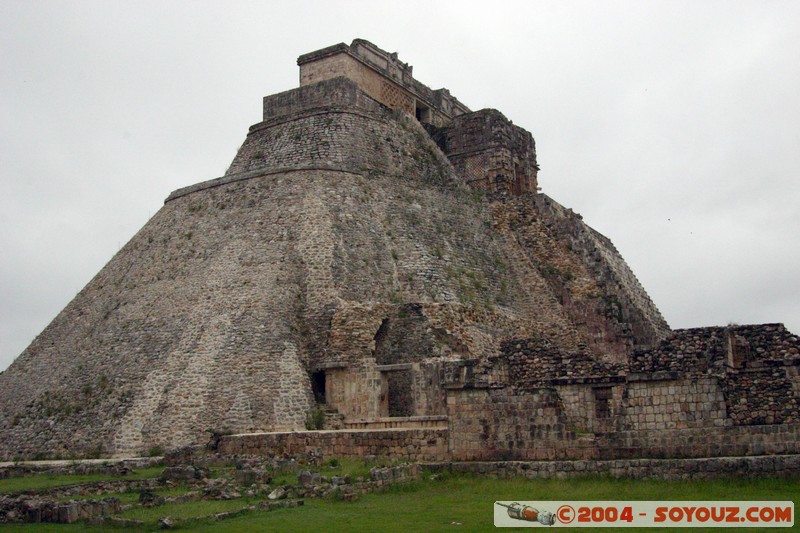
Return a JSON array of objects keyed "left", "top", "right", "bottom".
[{"left": 312, "top": 303, "right": 515, "bottom": 419}]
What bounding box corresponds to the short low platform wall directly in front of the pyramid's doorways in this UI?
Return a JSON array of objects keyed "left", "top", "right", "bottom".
[{"left": 218, "top": 429, "right": 448, "bottom": 461}]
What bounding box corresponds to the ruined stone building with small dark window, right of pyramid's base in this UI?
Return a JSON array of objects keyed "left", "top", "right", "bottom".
[{"left": 448, "top": 324, "right": 800, "bottom": 459}]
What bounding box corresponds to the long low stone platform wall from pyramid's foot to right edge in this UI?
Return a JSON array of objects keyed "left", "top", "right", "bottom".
[{"left": 218, "top": 422, "right": 800, "bottom": 461}]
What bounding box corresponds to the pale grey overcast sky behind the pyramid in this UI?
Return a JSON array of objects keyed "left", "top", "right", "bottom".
[{"left": 0, "top": 0, "right": 800, "bottom": 370}]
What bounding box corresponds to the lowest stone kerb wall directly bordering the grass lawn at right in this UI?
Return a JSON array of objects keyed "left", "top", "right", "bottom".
[{"left": 420, "top": 455, "right": 800, "bottom": 480}]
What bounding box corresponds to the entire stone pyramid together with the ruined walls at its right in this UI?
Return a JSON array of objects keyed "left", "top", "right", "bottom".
[{"left": 0, "top": 40, "right": 800, "bottom": 466}]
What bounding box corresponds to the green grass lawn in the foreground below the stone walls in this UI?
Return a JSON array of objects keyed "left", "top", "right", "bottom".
[{"left": 4, "top": 475, "right": 800, "bottom": 532}]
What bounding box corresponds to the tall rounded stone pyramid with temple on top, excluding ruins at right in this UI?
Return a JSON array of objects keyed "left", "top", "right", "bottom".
[{"left": 0, "top": 40, "right": 670, "bottom": 459}]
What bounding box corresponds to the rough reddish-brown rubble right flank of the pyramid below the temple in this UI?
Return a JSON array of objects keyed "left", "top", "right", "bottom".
[{"left": 478, "top": 189, "right": 669, "bottom": 362}]
